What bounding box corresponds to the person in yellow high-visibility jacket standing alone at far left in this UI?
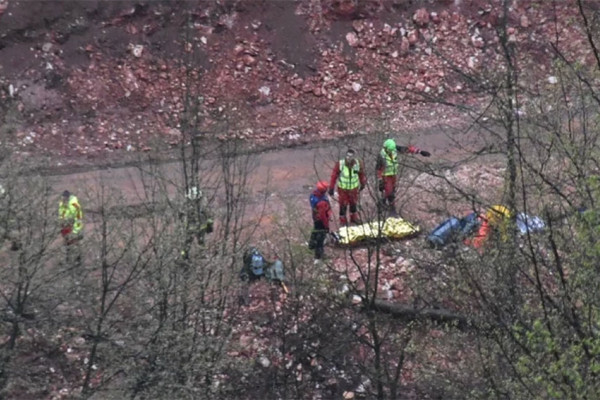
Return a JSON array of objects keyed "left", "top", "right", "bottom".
[{"left": 58, "top": 190, "right": 83, "bottom": 263}]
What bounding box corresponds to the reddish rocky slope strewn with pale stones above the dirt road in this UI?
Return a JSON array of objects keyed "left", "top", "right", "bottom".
[{"left": 0, "top": 0, "right": 591, "bottom": 161}]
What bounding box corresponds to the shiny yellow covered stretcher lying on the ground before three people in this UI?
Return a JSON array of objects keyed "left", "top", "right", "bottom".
[{"left": 338, "top": 217, "right": 419, "bottom": 245}]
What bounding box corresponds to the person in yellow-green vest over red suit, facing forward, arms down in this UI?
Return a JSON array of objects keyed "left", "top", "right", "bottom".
[{"left": 329, "top": 149, "right": 367, "bottom": 225}]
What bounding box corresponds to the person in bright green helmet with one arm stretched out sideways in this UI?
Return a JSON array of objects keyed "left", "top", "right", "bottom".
[{"left": 376, "top": 139, "right": 431, "bottom": 212}]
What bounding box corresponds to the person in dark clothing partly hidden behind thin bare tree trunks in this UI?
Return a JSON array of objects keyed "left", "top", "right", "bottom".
[{"left": 181, "top": 186, "right": 213, "bottom": 259}]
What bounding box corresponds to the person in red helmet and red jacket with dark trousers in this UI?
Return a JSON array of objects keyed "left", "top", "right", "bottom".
[{"left": 308, "top": 181, "right": 331, "bottom": 260}]
